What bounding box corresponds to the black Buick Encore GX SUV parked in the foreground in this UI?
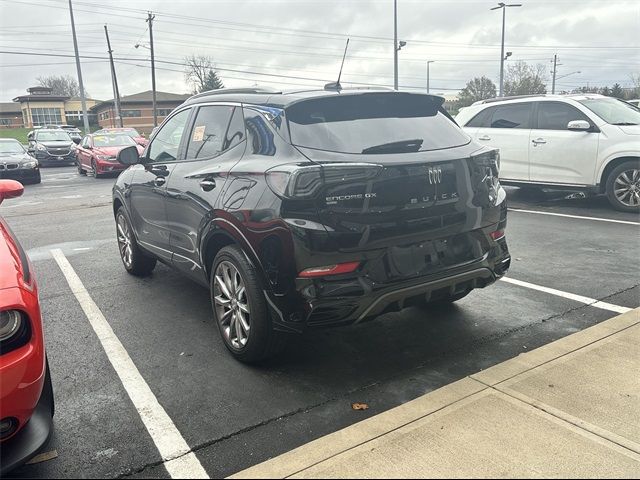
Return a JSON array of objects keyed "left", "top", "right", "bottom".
[{"left": 113, "top": 89, "right": 510, "bottom": 362}]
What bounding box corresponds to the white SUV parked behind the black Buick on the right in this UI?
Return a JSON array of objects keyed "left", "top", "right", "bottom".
[{"left": 456, "top": 94, "right": 640, "bottom": 212}]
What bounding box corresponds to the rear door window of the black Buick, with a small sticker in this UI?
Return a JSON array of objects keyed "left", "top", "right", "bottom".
[{"left": 187, "top": 105, "right": 245, "bottom": 159}]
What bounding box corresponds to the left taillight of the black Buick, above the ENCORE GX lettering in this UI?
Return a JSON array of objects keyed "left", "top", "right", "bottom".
[{"left": 265, "top": 163, "right": 383, "bottom": 199}]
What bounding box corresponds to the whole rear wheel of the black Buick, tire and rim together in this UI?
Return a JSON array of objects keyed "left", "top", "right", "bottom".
[{"left": 210, "top": 245, "right": 286, "bottom": 364}]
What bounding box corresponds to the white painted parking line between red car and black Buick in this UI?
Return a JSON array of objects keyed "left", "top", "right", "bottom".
[{"left": 51, "top": 249, "right": 209, "bottom": 478}]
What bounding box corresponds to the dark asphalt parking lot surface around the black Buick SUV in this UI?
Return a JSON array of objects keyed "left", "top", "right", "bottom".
[{"left": 5, "top": 167, "right": 640, "bottom": 478}]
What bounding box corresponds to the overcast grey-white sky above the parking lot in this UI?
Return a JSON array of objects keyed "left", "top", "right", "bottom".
[{"left": 0, "top": 0, "right": 640, "bottom": 102}]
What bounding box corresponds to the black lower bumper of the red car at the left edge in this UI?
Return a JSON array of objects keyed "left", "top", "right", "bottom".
[{"left": 0, "top": 369, "right": 53, "bottom": 476}]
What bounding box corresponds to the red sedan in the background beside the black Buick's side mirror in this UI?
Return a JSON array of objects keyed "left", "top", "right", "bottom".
[{"left": 76, "top": 133, "right": 144, "bottom": 178}]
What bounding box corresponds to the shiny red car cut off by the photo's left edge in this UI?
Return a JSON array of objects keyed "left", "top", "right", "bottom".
[{"left": 0, "top": 180, "right": 54, "bottom": 476}]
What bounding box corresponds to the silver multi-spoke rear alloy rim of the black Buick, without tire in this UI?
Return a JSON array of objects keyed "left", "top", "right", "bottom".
[{"left": 213, "top": 261, "right": 251, "bottom": 349}]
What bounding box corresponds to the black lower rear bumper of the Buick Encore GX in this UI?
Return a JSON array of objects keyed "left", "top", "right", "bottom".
[{"left": 268, "top": 226, "right": 511, "bottom": 332}]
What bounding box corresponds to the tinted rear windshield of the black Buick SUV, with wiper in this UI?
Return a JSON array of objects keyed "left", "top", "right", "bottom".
[{"left": 286, "top": 92, "right": 470, "bottom": 154}]
